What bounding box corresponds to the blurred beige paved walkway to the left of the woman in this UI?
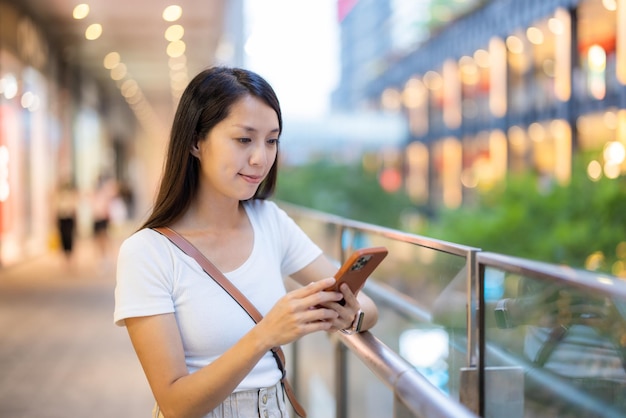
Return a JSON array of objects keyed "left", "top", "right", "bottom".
[{"left": 0, "top": 232, "right": 153, "bottom": 418}]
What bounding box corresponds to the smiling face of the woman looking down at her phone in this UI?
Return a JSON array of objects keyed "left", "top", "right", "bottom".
[{"left": 192, "top": 95, "right": 280, "bottom": 200}]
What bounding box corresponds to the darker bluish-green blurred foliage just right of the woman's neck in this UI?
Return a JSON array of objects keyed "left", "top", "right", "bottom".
[{"left": 275, "top": 160, "right": 411, "bottom": 229}]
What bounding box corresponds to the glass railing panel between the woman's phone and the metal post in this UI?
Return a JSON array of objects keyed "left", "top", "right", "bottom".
[{"left": 284, "top": 212, "right": 468, "bottom": 400}]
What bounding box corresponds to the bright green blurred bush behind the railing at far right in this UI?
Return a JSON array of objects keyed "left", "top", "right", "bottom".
[{"left": 422, "top": 158, "right": 626, "bottom": 273}]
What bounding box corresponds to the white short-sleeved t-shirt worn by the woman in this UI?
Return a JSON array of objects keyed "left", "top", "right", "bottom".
[{"left": 114, "top": 200, "right": 322, "bottom": 391}]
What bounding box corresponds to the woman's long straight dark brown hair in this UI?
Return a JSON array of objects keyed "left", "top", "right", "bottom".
[{"left": 140, "top": 67, "right": 283, "bottom": 229}]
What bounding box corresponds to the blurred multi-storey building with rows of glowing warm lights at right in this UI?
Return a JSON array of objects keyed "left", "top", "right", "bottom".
[{"left": 336, "top": 0, "right": 626, "bottom": 207}]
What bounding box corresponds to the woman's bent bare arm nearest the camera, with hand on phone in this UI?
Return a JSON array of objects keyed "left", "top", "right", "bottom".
[{"left": 151, "top": 279, "right": 340, "bottom": 418}]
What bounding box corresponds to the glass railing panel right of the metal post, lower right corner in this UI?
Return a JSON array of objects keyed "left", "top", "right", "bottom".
[{"left": 484, "top": 268, "right": 626, "bottom": 418}]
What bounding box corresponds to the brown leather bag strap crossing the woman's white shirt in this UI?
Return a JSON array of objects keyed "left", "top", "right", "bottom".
[{"left": 152, "top": 226, "right": 306, "bottom": 418}]
